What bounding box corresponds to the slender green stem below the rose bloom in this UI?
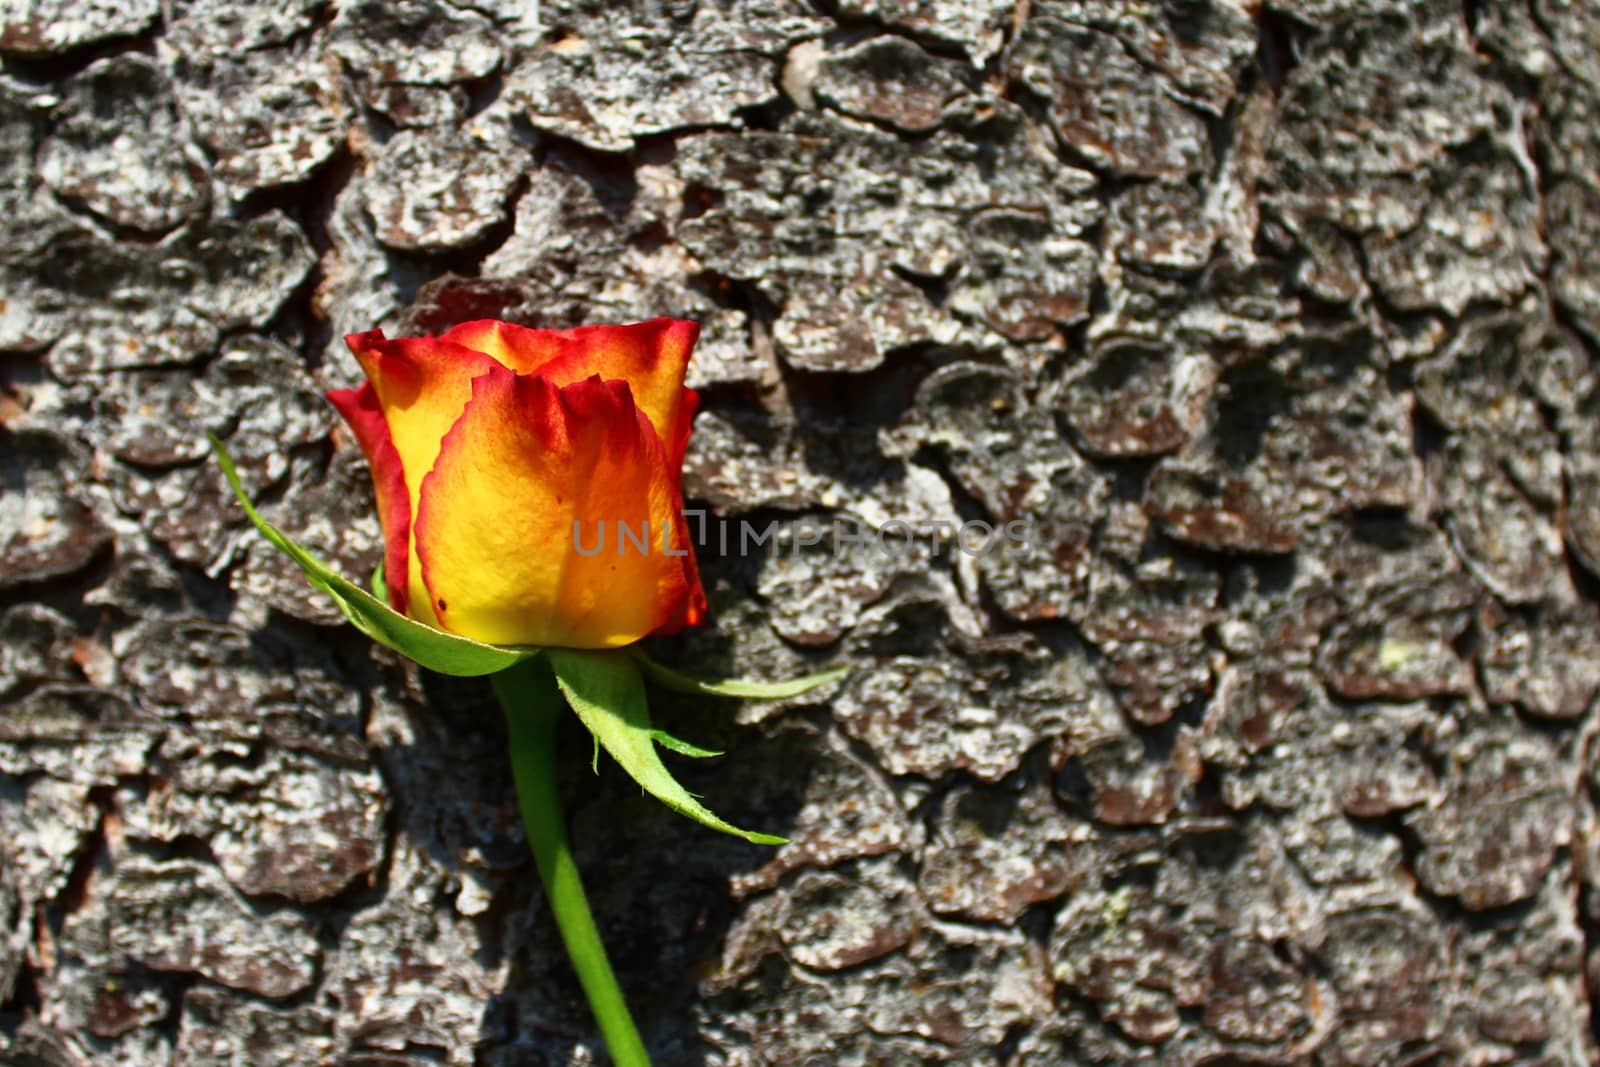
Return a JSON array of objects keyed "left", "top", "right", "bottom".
[{"left": 493, "top": 656, "right": 650, "bottom": 1067}]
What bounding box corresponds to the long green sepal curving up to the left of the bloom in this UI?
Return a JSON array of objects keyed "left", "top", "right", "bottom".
[{"left": 211, "top": 437, "right": 539, "bottom": 678}]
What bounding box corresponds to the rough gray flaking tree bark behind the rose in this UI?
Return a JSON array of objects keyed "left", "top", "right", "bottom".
[{"left": 0, "top": 0, "right": 1600, "bottom": 1067}]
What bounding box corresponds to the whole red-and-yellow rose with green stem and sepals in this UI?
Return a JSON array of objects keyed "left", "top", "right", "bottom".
[{"left": 211, "top": 310, "right": 843, "bottom": 1067}]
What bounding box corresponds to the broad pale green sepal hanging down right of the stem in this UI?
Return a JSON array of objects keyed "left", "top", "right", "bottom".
[{"left": 546, "top": 648, "right": 784, "bottom": 845}]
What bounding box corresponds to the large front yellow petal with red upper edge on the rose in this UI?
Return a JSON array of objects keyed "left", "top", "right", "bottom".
[{"left": 414, "top": 368, "right": 704, "bottom": 648}]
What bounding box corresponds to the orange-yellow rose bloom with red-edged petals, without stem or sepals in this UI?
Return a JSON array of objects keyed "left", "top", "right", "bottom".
[{"left": 328, "top": 318, "right": 706, "bottom": 648}]
